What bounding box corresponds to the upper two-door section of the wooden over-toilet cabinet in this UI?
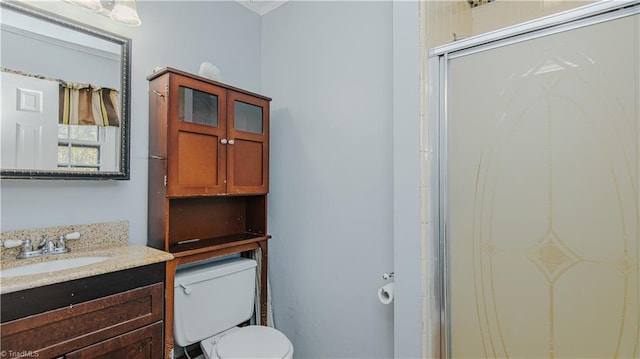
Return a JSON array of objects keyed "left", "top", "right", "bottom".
[{"left": 149, "top": 69, "right": 270, "bottom": 197}]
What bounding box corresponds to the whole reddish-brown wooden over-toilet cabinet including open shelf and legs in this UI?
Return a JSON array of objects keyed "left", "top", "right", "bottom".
[{"left": 147, "top": 68, "right": 271, "bottom": 358}]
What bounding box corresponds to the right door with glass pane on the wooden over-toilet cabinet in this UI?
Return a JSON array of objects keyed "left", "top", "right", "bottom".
[{"left": 227, "top": 91, "right": 269, "bottom": 194}]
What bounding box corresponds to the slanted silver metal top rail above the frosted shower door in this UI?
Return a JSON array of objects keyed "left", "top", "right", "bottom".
[{"left": 429, "top": 0, "right": 640, "bottom": 56}]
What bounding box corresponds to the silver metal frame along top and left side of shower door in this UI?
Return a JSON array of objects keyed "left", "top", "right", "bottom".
[{"left": 424, "top": 0, "right": 640, "bottom": 359}]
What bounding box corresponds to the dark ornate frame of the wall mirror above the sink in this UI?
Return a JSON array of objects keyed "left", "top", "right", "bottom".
[{"left": 0, "top": 0, "right": 131, "bottom": 180}]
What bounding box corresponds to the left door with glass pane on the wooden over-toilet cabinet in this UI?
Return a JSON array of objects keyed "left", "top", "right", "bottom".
[{"left": 167, "top": 75, "right": 227, "bottom": 196}]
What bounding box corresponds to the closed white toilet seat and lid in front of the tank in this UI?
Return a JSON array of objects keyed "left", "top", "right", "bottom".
[{"left": 200, "top": 325, "right": 293, "bottom": 359}]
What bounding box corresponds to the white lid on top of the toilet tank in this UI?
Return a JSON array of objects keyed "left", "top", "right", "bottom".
[{"left": 174, "top": 258, "right": 257, "bottom": 288}]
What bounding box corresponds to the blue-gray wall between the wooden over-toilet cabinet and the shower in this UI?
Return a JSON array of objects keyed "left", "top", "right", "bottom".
[{"left": 262, "top": 1, "right": 396, "bottom": 358}]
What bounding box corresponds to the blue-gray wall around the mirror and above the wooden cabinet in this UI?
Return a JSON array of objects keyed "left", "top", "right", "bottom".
[{"left": 0, "top": 1, "right": 261, "bottom": 244}]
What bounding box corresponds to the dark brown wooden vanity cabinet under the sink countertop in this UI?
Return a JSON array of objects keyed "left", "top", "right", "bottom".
[{"left": 0, "top": 263, "right": 165, "bottom": 359}]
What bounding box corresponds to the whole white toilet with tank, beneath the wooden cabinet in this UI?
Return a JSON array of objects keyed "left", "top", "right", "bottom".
[{"left": 174, "top": 258, "right": 293, "bottom": 359}]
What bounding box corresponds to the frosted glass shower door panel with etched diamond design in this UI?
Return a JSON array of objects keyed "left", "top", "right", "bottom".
[{"left": 446, "top": 9, "right": 640, "bottom": 358}]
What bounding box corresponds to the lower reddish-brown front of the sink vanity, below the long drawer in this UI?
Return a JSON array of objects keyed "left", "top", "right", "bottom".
[{"left": 64, "top": 322, "right": 164, "bottom": 359}]
